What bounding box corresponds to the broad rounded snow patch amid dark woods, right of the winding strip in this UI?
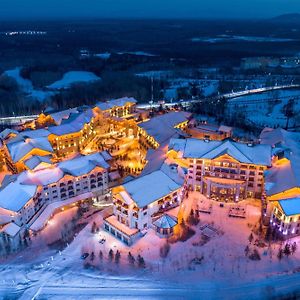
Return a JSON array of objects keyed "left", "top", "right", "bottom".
[{"left": 47, "top": 71, "right": 101, "bottom": 90}]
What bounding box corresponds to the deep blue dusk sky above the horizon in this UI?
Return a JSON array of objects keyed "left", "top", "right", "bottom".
[{"left": 0, "top": 0, "right": 300, "bottom": 20}]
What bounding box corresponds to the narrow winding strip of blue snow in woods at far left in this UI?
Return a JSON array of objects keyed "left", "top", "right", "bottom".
[{"left": 3, "top": 67, "right": 55, "bottom": 102}]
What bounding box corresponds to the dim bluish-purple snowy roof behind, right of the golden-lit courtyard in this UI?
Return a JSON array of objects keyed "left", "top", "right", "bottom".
[{"left": 139, "top": 111, "right": 191, "bottom": 144}]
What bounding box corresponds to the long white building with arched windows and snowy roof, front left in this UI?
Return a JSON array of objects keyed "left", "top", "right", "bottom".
[{"left": 0, "top": 153, "right": 110, "bottom": 239}]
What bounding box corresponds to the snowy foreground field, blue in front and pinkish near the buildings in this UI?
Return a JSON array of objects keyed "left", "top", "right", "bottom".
[{"left": 0, "top": 192, "right": 300, "bottom": 299}]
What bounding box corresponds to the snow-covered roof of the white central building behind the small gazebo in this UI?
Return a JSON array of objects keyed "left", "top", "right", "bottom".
[{"left": 123, "top": 170, "right": 181, "bottom": 207}]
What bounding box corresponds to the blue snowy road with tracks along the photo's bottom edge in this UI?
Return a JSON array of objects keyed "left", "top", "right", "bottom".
[{"left": 6, "top": 274, "right": 300, "bottom": 300}]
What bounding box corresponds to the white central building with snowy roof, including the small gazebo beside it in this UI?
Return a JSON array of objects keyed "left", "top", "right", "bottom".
[{"left": 104, "top": 164, "right": 184, "bottom": 245}]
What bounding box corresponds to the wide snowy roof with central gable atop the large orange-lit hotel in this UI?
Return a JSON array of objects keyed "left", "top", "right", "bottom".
[{"left": 169, "top": 139, "right": 272, "bottom": 166}]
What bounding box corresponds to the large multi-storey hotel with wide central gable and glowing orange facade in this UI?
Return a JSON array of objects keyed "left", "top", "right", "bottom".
[{"left": 168, "top": 139, "right": 272, "bottom": 202}]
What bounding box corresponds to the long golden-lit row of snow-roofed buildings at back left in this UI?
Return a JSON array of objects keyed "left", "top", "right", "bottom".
[{"left": 0, "top": 98, "right": 137, "bottom": 173}]
